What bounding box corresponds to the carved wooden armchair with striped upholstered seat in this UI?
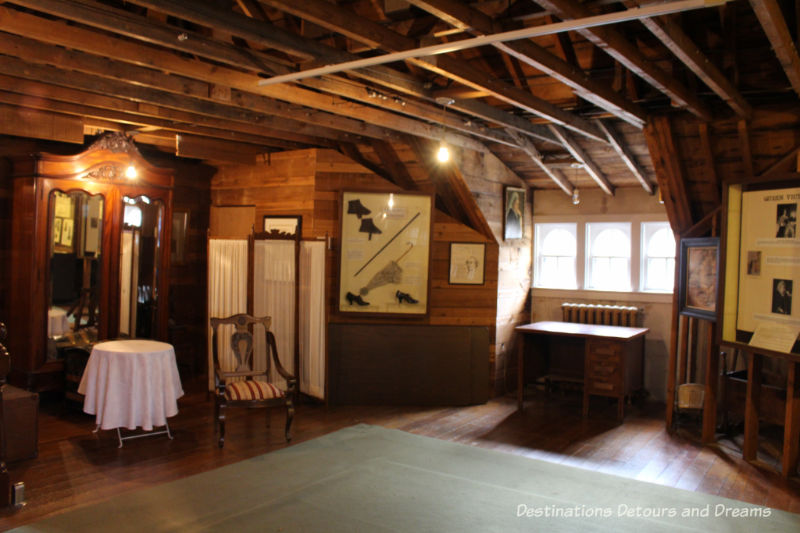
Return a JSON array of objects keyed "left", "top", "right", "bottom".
[{"left": 211, "top": 314, "right": 297, "bottom": 448}]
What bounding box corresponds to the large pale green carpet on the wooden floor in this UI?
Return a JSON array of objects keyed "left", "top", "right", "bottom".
[{"left": 14, "top": 425, "right": 800, "bottom": 533}]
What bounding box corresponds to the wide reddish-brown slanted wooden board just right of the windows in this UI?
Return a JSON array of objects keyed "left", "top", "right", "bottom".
[{"left": 644, "top": 115, "right": 693, "bottom": 236}]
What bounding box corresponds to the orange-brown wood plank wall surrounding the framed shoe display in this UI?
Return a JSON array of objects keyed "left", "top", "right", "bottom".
[{"left": 211, "top": 150, "right": 502, "bottom": 396}]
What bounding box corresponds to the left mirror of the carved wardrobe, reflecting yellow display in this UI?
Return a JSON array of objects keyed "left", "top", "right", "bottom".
[{"left": 47, "top": 190, "right": 104, "bottom": 352}]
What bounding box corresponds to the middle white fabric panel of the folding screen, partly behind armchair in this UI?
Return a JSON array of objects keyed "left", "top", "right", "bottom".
[{"left": 253, "top": 240, "right": 296, "bottom": 389}]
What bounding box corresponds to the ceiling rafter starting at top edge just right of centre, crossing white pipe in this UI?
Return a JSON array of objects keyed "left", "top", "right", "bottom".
[{"left": 410, "top": 0, "right": 645, "bottom": 129}]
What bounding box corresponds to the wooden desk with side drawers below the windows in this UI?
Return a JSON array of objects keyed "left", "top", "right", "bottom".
[{"left": 515, "top": 322, "right": 650, "bottom": 419}]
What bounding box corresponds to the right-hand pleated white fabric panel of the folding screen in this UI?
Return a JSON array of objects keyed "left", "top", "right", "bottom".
[{"left": 300, "top": 241, "right": 325, "bottom": 400}]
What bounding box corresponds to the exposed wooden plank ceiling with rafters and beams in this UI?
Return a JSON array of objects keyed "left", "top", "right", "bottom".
[{"left": 0, "top": 0, "right": 800, "bottom": 202}]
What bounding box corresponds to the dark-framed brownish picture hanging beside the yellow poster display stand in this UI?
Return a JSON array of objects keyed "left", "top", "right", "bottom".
[{"left": 678, "top": 237, "right": 719, "bottom": 322}]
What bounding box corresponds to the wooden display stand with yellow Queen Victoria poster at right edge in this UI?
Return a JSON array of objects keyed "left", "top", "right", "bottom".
[{"left": 717, "top": 173, "right": 800, "bottom": 477}]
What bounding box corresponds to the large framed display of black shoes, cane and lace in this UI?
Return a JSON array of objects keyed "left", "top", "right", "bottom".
[{"left": 338, "top": 192, "right": 432, "bottom": 316}]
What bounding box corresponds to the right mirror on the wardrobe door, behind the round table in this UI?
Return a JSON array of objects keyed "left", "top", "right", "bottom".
[{"left": 119, "top": 195, "right": 164, "bottom": 338}]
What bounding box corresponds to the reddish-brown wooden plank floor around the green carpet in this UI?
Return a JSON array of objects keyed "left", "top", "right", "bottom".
[{"left": 0, "top": 382, "right": 800, "bottom": 530}]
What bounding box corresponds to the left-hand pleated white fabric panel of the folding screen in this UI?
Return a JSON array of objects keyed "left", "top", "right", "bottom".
[{"left": 208, "top": 239, "right": 247, "bottom": 390}]
